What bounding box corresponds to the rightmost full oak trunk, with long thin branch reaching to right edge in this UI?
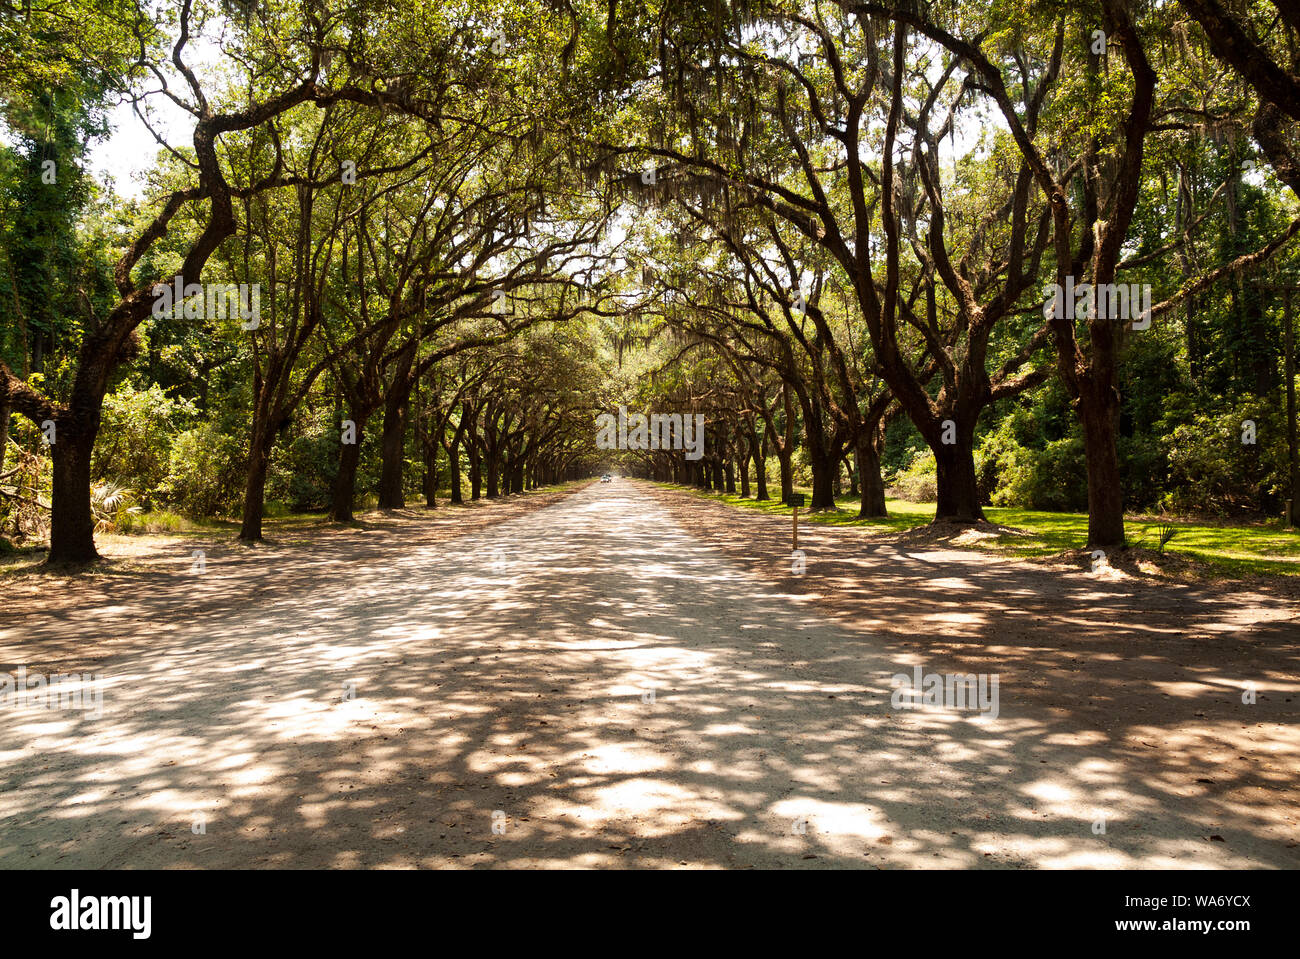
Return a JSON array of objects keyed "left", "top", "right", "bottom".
[{"left": 842, "top": 0, "right": 1296, "bottom": 548}]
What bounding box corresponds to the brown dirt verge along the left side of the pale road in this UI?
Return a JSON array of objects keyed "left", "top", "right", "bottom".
[{"left": 0, "top": 489, "right": 573, "bottom": 673}]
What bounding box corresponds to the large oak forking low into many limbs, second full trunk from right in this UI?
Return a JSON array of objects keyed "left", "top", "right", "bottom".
[{"left": 613, "top": 4, "right": 1050, "bottom": 520}]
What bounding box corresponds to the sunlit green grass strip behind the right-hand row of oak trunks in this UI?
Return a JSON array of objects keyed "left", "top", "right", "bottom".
[{"left": 666, "top": 483, "right": 1300, "bottom": 577}]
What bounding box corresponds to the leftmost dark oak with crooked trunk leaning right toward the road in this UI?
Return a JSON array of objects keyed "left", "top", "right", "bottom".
[{"left": 0, "top": 0, "right": 501, "bottom": 563}]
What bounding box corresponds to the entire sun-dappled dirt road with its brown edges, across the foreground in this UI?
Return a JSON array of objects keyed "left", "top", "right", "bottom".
[{"left": 0, "top": 482, "right": 1300, "bottom": 868}]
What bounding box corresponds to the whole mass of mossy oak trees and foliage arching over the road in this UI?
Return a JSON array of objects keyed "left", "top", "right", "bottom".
[{"left": 0, "top": 0, "right": 1300, "bottom": 561}]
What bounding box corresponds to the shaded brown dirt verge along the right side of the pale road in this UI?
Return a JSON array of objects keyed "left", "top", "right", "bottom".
[{"left": 646, "top": 487, "right": 1300, "bottom": 864}]
